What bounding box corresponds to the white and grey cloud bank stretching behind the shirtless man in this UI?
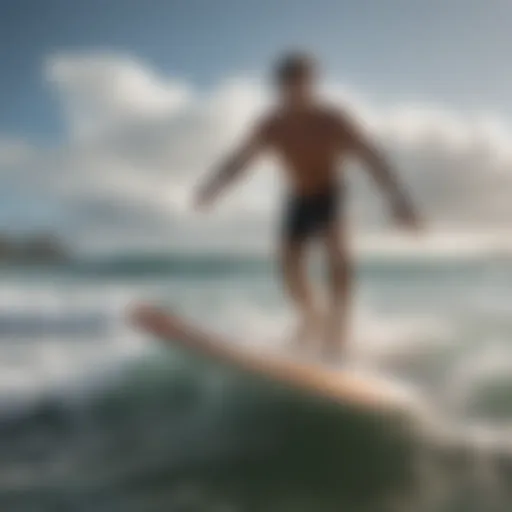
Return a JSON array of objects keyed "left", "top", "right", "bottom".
[{"left": 0, "top": 50, "right": 512, "bottom": 252}]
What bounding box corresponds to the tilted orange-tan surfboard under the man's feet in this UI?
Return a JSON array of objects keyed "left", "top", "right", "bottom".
[{"left": 130, "top": 304, "right": 410, "bottom": 410}]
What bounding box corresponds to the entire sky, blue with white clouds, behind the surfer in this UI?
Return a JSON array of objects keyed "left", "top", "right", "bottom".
[{"left": 0, "top": 0, "right": 512, "bottom": 254}]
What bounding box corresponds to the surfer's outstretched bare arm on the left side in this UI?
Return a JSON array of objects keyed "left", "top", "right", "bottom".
[{"left": 196, "top": 120, "right": 268, "bottom": 207}]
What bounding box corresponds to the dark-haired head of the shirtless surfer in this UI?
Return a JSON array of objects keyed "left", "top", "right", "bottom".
[{"left": 274, "top": 52, "right": 316, "bottom": 104}]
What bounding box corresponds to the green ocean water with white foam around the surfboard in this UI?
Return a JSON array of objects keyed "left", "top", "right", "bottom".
[{"left": 0, "top": 254, "right": 512, "bottom": 512}]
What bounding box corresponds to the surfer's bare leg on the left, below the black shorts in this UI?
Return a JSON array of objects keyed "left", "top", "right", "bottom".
[{"left": 281, "top": 241, "right": 319, "bottom": 345}]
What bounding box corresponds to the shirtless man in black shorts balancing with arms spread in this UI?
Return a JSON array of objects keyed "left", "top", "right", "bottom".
[{"left": 197, "top": 54, "right": 418, "bottom": 356}]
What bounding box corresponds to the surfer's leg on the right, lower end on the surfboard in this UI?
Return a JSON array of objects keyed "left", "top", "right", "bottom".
[{"left": 324, "top": 222, "right": 352, "bottom": 356}]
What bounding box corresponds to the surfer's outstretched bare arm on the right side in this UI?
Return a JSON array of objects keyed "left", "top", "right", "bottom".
[{"left": 343, "top": 117, "right": 419, "bottom": 227}]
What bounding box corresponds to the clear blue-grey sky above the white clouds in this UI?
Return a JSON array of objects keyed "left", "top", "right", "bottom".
[{"left": 0, "top": 0, "right": 512, "bottom": 139}]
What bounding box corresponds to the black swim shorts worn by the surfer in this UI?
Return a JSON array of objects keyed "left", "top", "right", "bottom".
[{"left": 283, "top": 186, "right": 341, "bottom": 242}]
